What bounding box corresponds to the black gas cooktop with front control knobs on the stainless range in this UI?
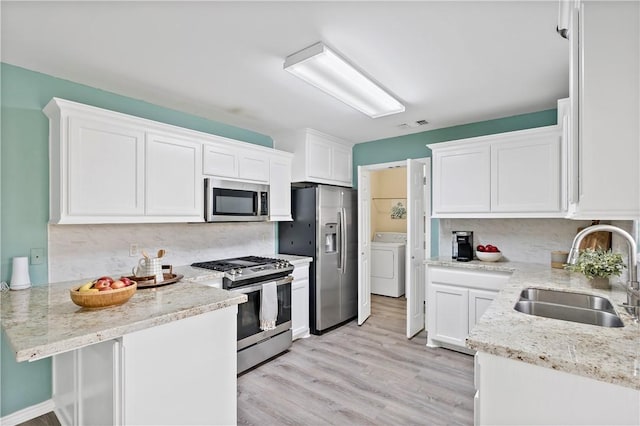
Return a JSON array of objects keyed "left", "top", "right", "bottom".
[{"left": 191, "top": 256, "right": 293, "bottom": 289}]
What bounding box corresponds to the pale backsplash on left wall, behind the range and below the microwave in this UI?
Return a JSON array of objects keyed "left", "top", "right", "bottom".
[{"left": 49, "top": 222, "right": 275, "bottom": 282}]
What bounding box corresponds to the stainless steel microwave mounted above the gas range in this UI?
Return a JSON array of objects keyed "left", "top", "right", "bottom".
[{"left": 204, "top": 178, "right": 269, "bottom": 222}]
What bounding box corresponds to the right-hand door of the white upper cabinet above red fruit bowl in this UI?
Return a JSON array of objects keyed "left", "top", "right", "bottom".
[{"left": 491, "top": 129, "right": 561, "bottom": 212}]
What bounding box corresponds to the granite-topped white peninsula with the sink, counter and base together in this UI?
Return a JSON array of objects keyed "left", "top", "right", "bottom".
[{"left": 426, "top": 258, "right": 640, "bottom": 424}]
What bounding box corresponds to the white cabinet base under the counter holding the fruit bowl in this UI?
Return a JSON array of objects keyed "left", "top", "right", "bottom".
[{"left": 53, "top": 305, "right": 237, "bottom": 425}]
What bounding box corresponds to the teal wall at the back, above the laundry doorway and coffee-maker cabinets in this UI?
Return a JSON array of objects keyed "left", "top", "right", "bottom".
[{"left": 353, "top": 109, "right": 557, "bottom": 256}]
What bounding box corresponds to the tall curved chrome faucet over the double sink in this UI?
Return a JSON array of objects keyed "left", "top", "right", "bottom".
[{"left": 567, "top": 225, "right": 640, "bottom": 320}]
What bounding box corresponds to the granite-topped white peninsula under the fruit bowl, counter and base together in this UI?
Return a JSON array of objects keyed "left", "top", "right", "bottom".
[{"left": 0, "top": 267, "right": 247, "bottom": 424}]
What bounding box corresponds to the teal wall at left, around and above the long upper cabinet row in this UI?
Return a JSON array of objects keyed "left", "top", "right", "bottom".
[{"left": 0, "top": 63, "right": 273, "bottom": 416}]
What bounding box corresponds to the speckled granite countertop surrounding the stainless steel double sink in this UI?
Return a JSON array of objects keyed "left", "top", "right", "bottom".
[{"left": 426, "top": 258, "right": 640, "bottom": 390}]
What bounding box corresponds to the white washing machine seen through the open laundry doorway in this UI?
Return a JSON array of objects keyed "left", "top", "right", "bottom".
[{"left": 370, "top": 232, "right": 407, "bottom": 297}]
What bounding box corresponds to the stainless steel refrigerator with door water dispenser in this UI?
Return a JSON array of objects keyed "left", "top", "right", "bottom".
[{"left": 278, "top": 185, "right": 358, "bottom": 334}]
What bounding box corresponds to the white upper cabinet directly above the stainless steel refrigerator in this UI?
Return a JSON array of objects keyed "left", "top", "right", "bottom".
[{"left": 274, "top": 129, "right": 353, "bottom": 187}]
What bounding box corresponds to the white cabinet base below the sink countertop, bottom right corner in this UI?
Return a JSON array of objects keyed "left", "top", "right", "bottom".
[{"left": 474, "top": 352, "right": 640, "bottom": 425}]
